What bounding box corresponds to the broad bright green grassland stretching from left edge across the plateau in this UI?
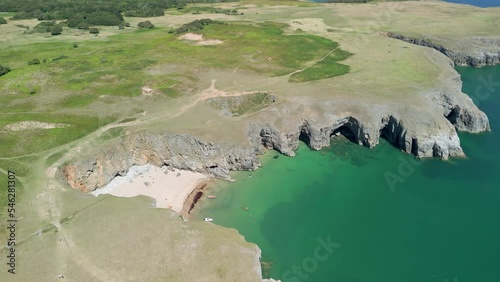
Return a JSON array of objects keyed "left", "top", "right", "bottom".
[{"left": 0, "top": 23, "right": 352, "bottom": 111}]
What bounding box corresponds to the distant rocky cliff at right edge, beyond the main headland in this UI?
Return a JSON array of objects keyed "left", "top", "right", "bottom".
[{"left": 382, "top": 32, "right": 500, "bottom": 67}]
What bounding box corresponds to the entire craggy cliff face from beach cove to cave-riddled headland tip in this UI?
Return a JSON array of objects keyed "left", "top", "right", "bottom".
[{"left": 62, "top": 80, "right": 490, "bottom": 191}]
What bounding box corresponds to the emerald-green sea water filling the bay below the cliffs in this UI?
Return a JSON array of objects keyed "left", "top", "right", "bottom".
[{"left": 196, "top": 66, "right": 500, "bottom": 282}]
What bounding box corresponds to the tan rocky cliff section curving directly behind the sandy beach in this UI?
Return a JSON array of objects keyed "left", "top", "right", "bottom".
[{"left": 62, "top": 132, "right": 259, "bottom": 192}]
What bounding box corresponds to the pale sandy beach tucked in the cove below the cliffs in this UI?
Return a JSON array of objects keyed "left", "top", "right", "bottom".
[{"left": 92, "top": 164, "right": 208, "bottom": 213}]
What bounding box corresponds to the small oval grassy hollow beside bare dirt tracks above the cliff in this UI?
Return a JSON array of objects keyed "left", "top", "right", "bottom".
[{"left": 207, "top": 92, "right": 277, "bottom": 116}]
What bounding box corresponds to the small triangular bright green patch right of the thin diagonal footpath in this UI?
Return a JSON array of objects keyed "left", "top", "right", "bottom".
[{"left": 289, "top": 49, "right": 351, "bottom": 82}]
